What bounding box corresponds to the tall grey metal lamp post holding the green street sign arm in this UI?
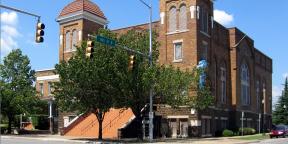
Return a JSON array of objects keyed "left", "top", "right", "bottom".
[{"left": 139, "top": 0, "right": 154, "bottom": 142}]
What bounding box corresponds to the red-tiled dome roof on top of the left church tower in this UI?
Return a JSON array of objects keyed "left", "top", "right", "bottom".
[{"left": 59, "top": 0, "right": 107, "bottom": 20}]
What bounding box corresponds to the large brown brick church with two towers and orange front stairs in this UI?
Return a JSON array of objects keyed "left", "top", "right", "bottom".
[{"left": 36, "top": 0, "right": 272, "bottom": 138}]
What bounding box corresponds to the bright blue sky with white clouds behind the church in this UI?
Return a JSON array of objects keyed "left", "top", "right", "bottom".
[{"left": 0, "top": 0, "right": 288, "bottom": 106}]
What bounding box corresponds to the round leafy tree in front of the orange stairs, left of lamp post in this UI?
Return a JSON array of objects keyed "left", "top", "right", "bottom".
[{"left": 54, "top": 29, "right": 128, "bottom": 140}]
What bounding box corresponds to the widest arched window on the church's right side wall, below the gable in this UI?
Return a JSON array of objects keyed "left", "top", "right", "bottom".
[{"left": 241, "top": 64, "right": 250, "bottom": 105}]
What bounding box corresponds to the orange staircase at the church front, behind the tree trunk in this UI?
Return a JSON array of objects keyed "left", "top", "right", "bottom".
[{"left": 63, "top": 108, "right": 135, "bottom": 139}]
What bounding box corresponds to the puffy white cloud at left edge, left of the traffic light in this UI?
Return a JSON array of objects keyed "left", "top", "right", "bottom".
[{"left": 1, "top": 12, "right": 21, "bottom": 57}]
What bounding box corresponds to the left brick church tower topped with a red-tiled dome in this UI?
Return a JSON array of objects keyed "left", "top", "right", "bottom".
[{"left": 57, "top": 0, "right": 108, "bottom": 61}]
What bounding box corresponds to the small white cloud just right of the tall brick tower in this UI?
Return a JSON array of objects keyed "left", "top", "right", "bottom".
[{"left": 214, "top": 9, "right": 234, "bottom": 26}]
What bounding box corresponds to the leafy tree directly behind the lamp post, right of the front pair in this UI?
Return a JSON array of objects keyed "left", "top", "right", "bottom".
[{"left": 115, "top": 30, "right": 213, "bottom": 139}]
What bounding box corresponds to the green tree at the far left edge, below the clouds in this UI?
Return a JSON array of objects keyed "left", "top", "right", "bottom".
[{"left": 0, "top": 49, "right": 39, "bottom": 133}]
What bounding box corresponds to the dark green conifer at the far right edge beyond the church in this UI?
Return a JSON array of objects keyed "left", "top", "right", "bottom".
[{"left": 272, "top": 78, "right": 288, "bottom": 124}]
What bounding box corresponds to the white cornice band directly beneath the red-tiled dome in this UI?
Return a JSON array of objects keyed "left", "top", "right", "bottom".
[{"left": 57, "top": 11, "right": 109, "bottom": 26}]
